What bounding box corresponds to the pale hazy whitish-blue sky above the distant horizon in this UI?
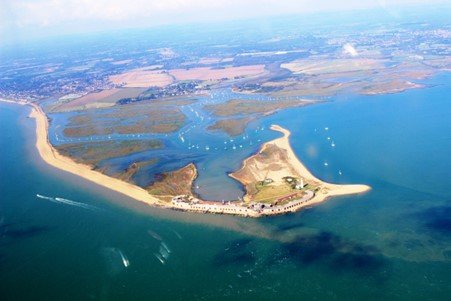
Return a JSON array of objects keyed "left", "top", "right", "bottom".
[{"left": 0, "top": 0, "right": 446, "bottom": 46}]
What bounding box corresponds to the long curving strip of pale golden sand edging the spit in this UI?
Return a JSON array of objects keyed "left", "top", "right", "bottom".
[{"left": 21, "top": 103, "right": 370, "bottom": 217}]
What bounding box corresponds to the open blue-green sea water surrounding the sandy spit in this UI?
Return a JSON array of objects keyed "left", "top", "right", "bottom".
[{"left": 0, "top": 75, "right": 451, "bottom": 300}]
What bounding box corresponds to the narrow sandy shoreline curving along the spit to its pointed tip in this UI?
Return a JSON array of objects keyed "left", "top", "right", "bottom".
[{"left": 23, "top": 101, "right": 370, "bottom": 217}]
